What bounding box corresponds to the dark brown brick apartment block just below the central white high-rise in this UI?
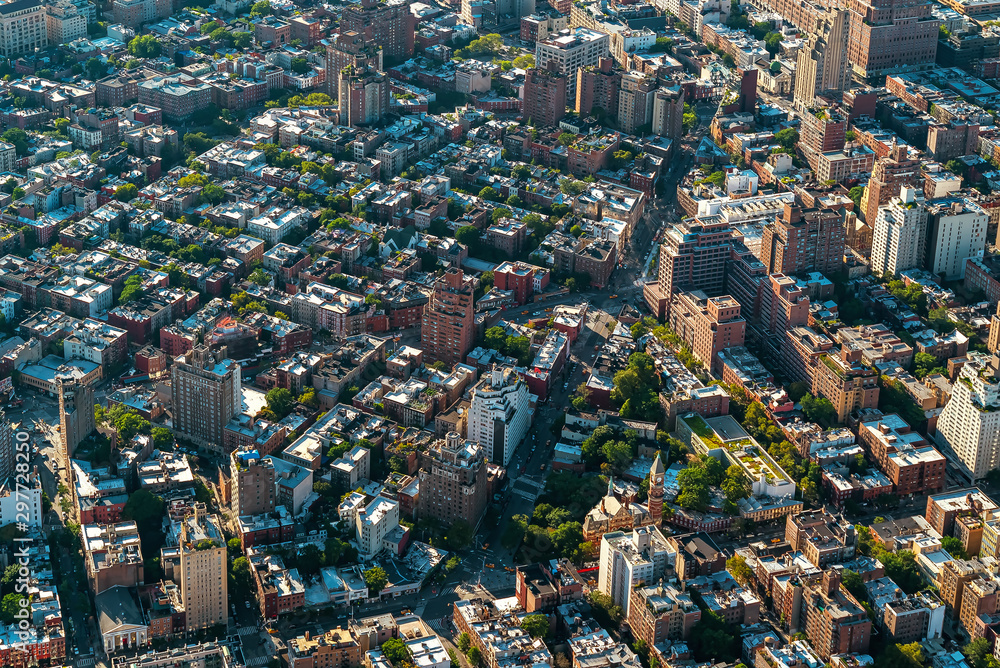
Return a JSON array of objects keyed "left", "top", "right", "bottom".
[{"left": 416, "top": 431, "right": 490, "bottom": 527}]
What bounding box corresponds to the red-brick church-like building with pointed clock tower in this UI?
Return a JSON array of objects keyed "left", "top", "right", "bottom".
[{"left": 583, "top": 454, "right": 664, "bottom": 544}]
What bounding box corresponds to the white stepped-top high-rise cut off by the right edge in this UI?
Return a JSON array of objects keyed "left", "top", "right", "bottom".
[{"left": 937, "top": 353, "right": 1000, "bottom": 480}]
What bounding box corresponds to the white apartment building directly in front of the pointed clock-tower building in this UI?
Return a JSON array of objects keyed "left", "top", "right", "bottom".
[{"left": 597, "top": 525, "right": 677, "bottom": 616}]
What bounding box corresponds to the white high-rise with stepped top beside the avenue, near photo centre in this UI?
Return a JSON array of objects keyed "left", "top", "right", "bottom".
[{"left": 468, "top": 368, "right": 531, "bottom": 466}]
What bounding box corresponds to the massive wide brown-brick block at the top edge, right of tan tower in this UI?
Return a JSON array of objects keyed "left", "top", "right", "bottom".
[{"left": 847, "top": 0, "right": 941, "bottom": 79}]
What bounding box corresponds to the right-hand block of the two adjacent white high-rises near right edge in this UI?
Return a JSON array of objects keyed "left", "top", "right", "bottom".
[{"left": 927, "top": 198, "right": 990, "bottom": 281}]
